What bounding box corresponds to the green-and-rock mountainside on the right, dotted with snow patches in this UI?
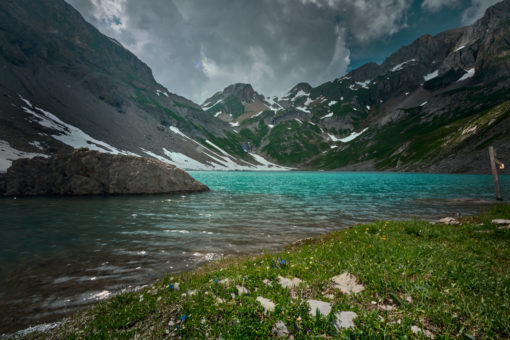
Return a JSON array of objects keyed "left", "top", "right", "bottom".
[{"left": 218, "top": 1, "right": 510, "bottom": 172}]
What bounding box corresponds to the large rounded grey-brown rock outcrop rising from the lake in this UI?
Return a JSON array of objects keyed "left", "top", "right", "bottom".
[{"left": 0, "top": 150, "right": 209, "bottom": 196}]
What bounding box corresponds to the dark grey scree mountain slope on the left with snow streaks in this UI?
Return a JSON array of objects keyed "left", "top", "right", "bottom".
[{"left": 0, "top": 0, "right": 276, "bottom": 170}]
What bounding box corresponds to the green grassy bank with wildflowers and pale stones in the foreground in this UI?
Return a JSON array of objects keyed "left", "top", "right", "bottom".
[{"left": 43, "top": 205, "right": 510, "bottom": 338}]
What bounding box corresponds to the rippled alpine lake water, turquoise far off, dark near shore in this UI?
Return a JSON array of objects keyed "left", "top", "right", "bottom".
[{"left": 0, "top": 172, "right": 510, "bottom": 333}]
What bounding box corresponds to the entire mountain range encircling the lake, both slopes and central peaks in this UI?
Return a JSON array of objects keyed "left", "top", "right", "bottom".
[{"left": 0, "top": 0, "right": 510, "bottom": 172}]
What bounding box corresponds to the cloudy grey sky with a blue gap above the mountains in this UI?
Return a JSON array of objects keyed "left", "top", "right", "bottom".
[{"left": 66, "top": 0, "right": 499, "bottom": 104}]
